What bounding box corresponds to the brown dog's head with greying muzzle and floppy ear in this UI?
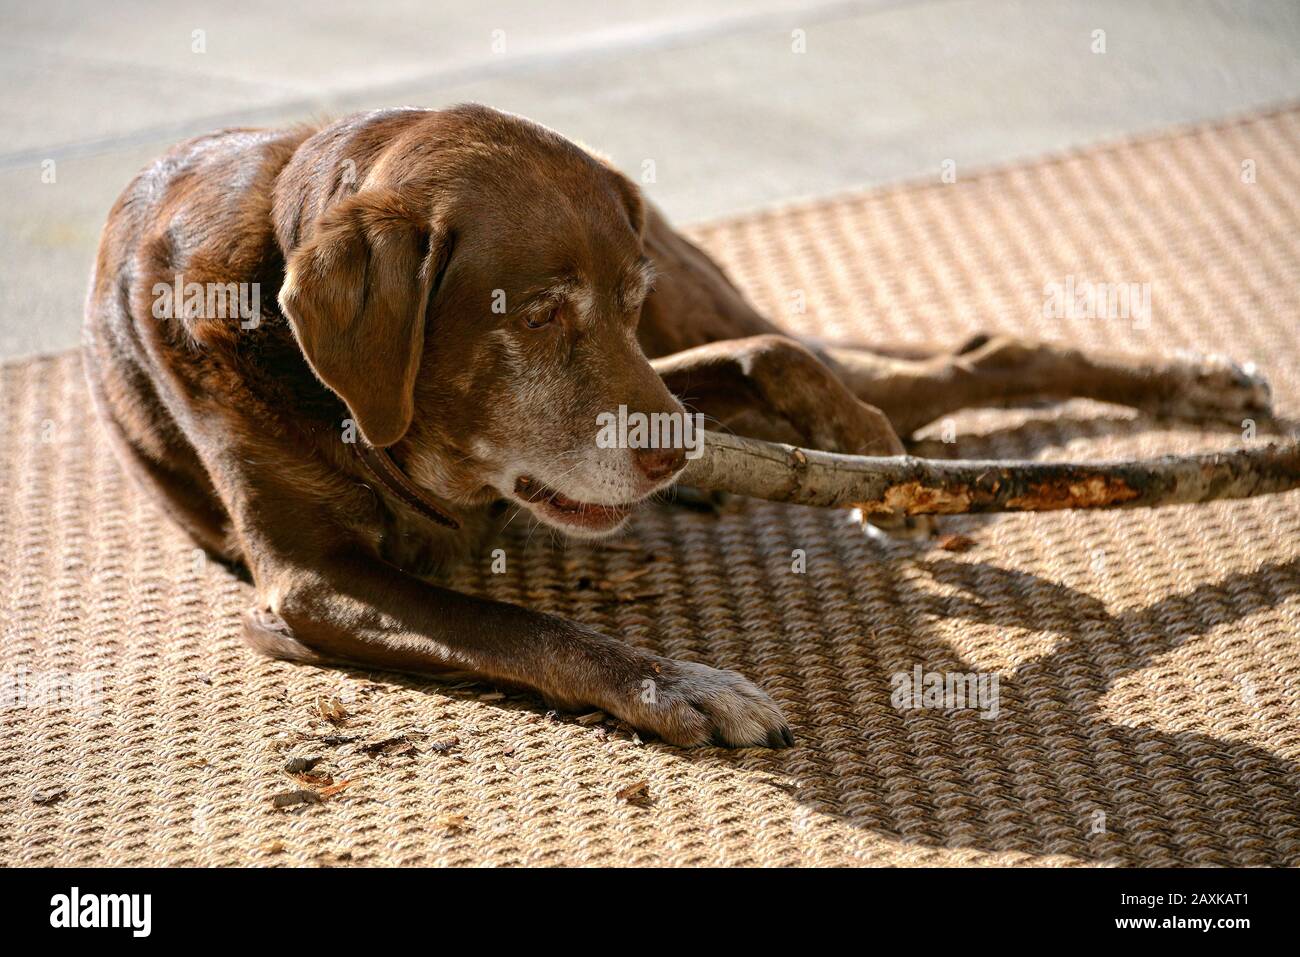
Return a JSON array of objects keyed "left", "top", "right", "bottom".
[{"left": 274, "top": 107, "right": 690, "bottom": 536}]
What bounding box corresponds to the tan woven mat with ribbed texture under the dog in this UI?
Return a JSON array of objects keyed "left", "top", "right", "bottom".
[{"left": 0, "top": 111, "right": 1300, "bottom": 865}]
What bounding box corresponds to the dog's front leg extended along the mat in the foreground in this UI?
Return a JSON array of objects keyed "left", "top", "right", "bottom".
[{"left": 222, "top": 456, "right": 793, "bottom": 748}]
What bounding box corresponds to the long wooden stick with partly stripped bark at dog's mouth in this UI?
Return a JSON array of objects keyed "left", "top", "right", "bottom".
[{"left": 680, "top": 432, "right": 1300, "bottom": 515}]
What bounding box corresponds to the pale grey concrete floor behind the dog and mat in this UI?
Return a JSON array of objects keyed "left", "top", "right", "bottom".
[{"left": 0, "top": 0, "right": 1300, "bottom": 356}]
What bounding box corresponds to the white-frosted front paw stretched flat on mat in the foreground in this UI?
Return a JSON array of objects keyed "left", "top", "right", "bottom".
[{"left": 607, "top": 657, "right": 794, "bottom": 748}]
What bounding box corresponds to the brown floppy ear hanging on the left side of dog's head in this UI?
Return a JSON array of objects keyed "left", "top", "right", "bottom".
[{"left": 280, "top": 189, "right": 452, "bottom": 449}]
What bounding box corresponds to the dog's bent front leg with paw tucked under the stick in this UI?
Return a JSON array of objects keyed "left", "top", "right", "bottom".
[{"left": 651, "top": 335, "right": 933, "bottom": 536}]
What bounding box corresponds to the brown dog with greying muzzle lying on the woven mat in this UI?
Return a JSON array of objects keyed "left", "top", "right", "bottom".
[{"left": 86, "top": 107, "right": 1268, "bottom": 746}]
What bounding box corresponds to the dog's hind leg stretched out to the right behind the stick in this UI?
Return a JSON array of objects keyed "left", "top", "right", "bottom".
[{"left": 822, "top": 335, "right": 1269, "bottom": 436}]
